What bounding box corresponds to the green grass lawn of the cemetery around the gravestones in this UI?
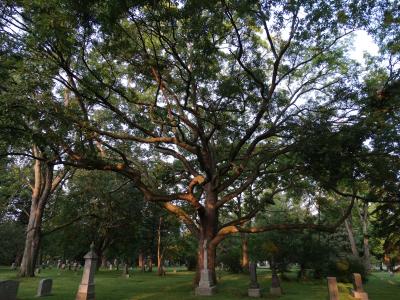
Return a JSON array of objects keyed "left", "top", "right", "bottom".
[{"left": 0, "top": 267, "right": 400, "bottom": 300}]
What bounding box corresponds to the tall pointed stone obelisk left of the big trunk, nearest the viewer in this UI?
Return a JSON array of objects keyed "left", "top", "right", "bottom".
[{"left": 75, "top": 243, "right": 97, "bottom": 300}]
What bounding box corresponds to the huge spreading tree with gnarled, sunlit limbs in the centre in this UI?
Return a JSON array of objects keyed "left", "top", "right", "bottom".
[{"left": 2, "top": 0, "right": 382, "bottom": 282}]
